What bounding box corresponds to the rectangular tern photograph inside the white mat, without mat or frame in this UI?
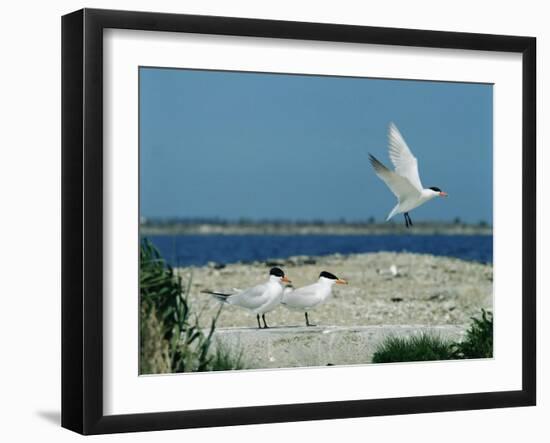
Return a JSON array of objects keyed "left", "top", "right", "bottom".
[{"left": 136, "top": 66, "right": 494, "bottom": 375}]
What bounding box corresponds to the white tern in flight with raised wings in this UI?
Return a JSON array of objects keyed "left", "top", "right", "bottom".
[{"left": 369, "top": 123, "right": 447, "bottom": 228}]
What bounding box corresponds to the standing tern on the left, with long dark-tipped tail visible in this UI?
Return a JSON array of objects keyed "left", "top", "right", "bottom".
[{"left": 202, "top": 268, "right": 290, "bottom": 329}]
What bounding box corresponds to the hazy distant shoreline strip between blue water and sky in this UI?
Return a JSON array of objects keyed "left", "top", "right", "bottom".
[{"left": 140, "top": 222, "right": 493, "bottom": 236}]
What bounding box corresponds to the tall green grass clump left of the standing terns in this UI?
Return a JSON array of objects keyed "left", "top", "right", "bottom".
[{"left": 140, "top": 239, "right": 245, "bottom": 374}]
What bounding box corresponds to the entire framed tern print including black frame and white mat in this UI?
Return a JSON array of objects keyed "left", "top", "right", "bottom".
[{"left": 62, "top": 9, "right": 536, "bottom": 434}]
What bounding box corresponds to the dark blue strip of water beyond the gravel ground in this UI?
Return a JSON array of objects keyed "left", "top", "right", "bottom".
[{"left": 147, "top": 234, "right": 493, "bottom": 267}]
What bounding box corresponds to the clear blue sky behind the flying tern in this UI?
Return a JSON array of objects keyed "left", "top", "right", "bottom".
[{"left": 140, "top": 68, "right": 493, "bottom": 223}]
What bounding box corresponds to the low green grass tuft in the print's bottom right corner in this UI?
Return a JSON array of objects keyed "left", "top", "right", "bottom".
[{"left": 372, "top": 309, "right": 493, "bottom": 363}]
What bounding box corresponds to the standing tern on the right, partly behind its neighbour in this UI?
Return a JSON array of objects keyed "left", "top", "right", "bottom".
[{"left": 281, "top": 271, "right": 347, "bottom": 326}]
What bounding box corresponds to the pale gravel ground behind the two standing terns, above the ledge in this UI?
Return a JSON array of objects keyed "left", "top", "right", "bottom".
[{"left": 177, "top": 252, "right": 493, "bottom": 327}]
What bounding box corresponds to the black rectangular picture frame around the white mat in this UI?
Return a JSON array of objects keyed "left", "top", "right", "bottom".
[{"left": 62, "top": 9, "right": 536, "bottom": 434}]
